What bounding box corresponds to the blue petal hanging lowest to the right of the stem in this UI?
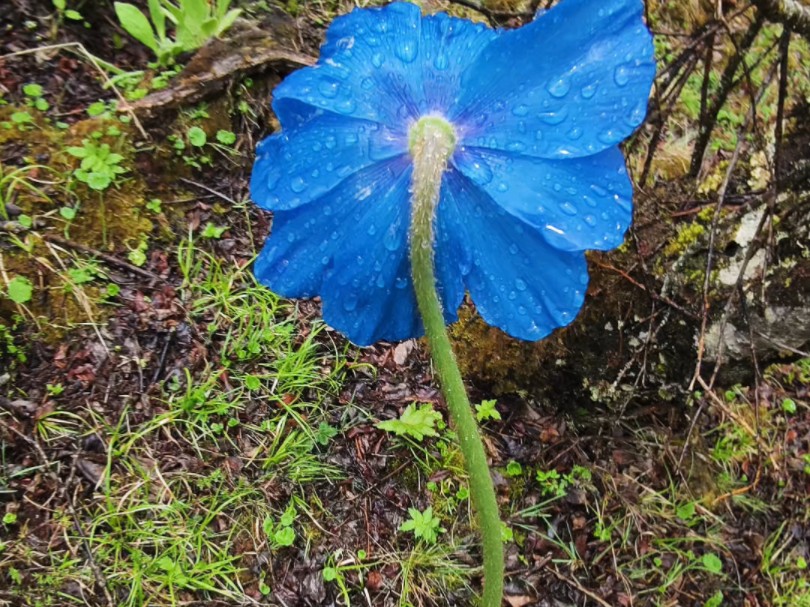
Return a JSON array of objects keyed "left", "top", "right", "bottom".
[{"left": 440, "top": 170, "right": 588, "bottom": 341}]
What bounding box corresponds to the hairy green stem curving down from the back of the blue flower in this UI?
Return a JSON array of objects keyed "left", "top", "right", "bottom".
[{"left": 410, "top": 117, "right": 504, "bottom": 607}]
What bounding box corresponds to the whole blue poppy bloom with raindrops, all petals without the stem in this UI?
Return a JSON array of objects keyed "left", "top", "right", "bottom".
[{"left": 251, "top": 0, "right": 655, "bottom": 345}]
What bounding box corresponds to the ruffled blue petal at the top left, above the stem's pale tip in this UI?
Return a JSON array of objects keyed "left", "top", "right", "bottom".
[{"left": 273, "top": 2, "right": 498, "bottom": 133}]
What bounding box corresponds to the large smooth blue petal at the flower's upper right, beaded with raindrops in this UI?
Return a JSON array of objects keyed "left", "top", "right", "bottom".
[{"left": 450, "top": 0, "right": 655, "bottom": 158}]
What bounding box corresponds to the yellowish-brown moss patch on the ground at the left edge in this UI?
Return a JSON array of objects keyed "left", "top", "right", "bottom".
[{"left": 0, "top": 113, "right": 161, "bottom": 339}]
